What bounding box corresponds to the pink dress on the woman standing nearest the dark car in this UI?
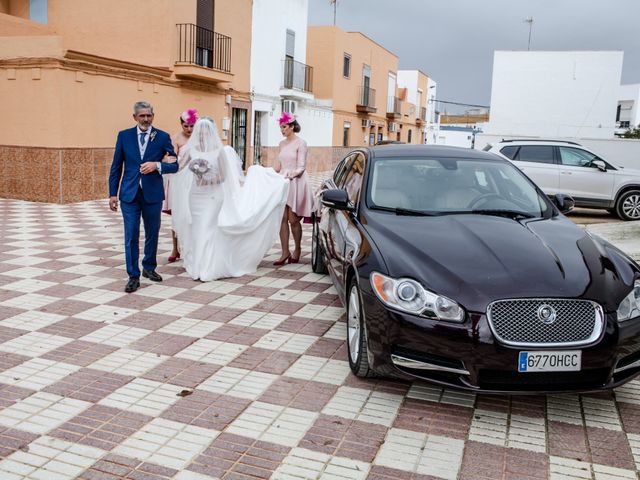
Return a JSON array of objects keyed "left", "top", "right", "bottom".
[{"left": 278, "top": 137, "right": 313, "bottom": 217}]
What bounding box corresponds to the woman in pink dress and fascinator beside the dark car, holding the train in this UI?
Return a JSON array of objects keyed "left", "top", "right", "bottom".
[{"left": 273, "top": 112, "right": 313, "bottom": 266}]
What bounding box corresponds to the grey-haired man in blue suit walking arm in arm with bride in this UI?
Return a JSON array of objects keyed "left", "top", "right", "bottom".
[{"left": 109, "top": 102, "right": 178, "bottom": 293}]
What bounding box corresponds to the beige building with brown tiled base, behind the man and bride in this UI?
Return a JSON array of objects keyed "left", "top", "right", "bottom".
[{"left": 0, "top": 0, "right": 252, "bottom": 203}]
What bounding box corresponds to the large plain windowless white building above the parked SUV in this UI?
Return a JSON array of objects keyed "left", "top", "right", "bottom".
[{"left": 485, "top": 51, "right": 623, "bottom": 138}]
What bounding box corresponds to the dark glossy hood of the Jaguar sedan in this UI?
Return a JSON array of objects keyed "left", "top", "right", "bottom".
[{"left": 363, "top": 212, "right": 637, "bottom": 312}]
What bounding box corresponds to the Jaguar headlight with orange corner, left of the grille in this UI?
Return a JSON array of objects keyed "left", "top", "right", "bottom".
[{"left": 371, "top": 272, "right": 464, "bottom": 322}]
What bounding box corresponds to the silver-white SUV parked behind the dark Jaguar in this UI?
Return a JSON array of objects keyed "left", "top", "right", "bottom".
[{"left": 484, "top": 139, "right": 640, "bottom": 220}]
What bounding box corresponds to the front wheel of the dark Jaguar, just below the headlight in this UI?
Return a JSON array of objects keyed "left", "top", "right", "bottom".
[{"left": 347, "top": 279, "right": 375, "bottom": 377}]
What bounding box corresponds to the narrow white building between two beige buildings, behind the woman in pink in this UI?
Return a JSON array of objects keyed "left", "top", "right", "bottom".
[{"left": 251, "top": 0, "right": 333, "bottom": 163}]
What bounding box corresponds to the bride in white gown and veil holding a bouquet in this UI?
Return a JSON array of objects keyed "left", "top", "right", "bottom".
[{"left": 171, "top": 117, "right": 289, "bottom": 281}]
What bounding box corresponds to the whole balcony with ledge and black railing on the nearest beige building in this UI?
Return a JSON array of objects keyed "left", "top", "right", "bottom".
[{"left": 175, "top": 23, "right": 233, "bottom": 83}]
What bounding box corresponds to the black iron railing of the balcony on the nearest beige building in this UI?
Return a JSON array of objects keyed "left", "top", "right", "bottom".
[{"left": 176, "top": 23, "right": 231, "bottom": 73}]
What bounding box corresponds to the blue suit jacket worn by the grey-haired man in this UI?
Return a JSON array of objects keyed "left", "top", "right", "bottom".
[{"left": 109, "top": 127, "right": 178, "bottom": 203}]
